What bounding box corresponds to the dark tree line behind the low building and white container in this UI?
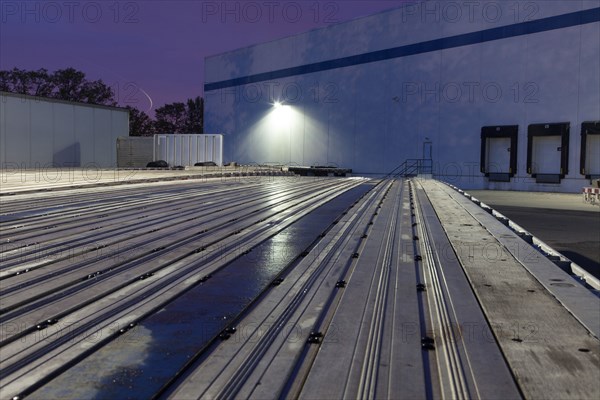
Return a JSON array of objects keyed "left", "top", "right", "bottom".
[{"left": 0, "top": 68, "right": 204, "bottom": 136}]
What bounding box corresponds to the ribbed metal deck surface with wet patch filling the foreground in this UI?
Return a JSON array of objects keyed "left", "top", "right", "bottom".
[{"left": 0, "top": 176, "right": 600, "bottom": 399}]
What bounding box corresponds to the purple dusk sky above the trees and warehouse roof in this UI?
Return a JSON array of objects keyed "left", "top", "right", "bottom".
[{"left": 0, "top": 0, "right": 403, "bottom": 115}]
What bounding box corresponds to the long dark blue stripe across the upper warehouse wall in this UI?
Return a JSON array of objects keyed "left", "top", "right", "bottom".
[{"left": 204, "top": 7, "right": 600, "bottom": 92}]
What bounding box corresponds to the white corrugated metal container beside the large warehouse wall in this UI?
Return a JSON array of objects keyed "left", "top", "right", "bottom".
[{"left": 154, "top": 134, "right": 223, "bottom": 166}]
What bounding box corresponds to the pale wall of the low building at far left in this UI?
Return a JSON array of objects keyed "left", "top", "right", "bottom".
[{"left": 0, "top": 92, "right": 129, "bottom": 169}]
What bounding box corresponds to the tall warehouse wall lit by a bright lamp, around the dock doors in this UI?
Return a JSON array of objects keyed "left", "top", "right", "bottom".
[{"left": 205, "top": 0, "right": 600, "bottom": 191}]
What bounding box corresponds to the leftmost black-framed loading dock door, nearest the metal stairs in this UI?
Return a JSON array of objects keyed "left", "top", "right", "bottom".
[{"left": 480, "top": 125, "right": 519, "bottom": 182}]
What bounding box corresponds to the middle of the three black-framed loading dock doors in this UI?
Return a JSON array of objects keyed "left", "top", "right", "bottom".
[{"left": 527, "top": 122, "right": 570, "bottom": 183}]
